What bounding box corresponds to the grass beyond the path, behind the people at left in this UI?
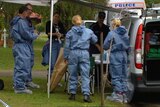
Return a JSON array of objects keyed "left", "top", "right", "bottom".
[{"left": 0, "top": 36, "right": 47, "bottom": 71}]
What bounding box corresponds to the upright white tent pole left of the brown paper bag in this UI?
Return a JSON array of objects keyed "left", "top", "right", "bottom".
[{"left": 47, "top": 0, "right": 54, "bottom": 98}]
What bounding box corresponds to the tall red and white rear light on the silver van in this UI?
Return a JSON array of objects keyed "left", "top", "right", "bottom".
[{"left": 135, "top": 24, "right": 143, "bottom": 69}]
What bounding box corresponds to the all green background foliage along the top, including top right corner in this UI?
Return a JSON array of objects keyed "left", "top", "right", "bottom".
[{"left": 0, "top": 0, "right": 160, "bottom": 32}]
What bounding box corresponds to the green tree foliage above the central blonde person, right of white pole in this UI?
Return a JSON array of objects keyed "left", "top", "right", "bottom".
[{"left": 55, "top": 0, "right": 106, "bottom": 29}]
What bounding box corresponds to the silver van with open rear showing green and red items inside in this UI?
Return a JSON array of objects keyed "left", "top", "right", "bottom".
[{"left": 128, "top": 12, "right": 160, "bottom": 88}]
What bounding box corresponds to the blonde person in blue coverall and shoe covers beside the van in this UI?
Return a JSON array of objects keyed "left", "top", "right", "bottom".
[{"left": 103, "top": 18, "right": 129, "bottom": 103}]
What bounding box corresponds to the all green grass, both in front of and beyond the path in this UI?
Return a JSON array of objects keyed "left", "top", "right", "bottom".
[{"left": 0, "top": 36, "right": 127, "bottom": 107}]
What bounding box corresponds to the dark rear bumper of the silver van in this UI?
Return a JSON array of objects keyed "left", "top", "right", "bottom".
[{"left": 131, "top": 73, "right": 160, "bottom": 92}]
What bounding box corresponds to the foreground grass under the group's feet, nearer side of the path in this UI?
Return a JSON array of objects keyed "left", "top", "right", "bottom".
[{"left": 0, "top": 77, "right": 127, "bottom": 107}]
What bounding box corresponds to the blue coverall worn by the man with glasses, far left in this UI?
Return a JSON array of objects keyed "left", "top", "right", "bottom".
[{"left": 10, "top": 16, "right": 38, "bottom": 90}]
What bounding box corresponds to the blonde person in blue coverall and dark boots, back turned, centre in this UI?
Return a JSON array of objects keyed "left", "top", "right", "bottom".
[{"left": 64, "top": 15, "right": 97, "bottom": 102}]
